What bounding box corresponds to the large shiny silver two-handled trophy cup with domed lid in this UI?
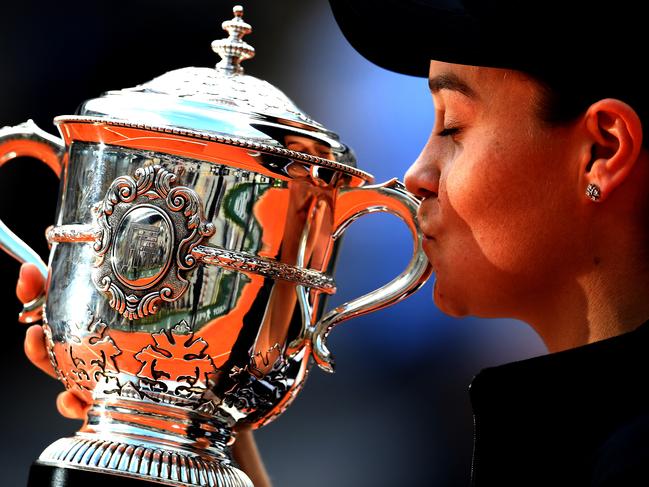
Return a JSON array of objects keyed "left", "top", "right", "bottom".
[{"left": 0, "top": 7, "right": 431, "bottom": 487}]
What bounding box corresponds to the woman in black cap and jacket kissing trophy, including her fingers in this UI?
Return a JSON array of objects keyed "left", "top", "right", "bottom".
[{"left": 18, "top": 0, "right": 649, "bottom": 486}]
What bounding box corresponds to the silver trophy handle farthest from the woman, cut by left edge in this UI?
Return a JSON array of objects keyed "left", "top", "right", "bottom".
[{"left": 0, "top": 120, "right": 65, "bottom": 323}]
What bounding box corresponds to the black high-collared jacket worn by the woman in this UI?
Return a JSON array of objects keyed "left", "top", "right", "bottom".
[{"left": 470, "top": 322, "right": 649, "bottom": 487}]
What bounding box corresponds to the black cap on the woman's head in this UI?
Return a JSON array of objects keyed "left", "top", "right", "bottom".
[{"left": 330, "top": 0, "right": 649, "bottom": 121}]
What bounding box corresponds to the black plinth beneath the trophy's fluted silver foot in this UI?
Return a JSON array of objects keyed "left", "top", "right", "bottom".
[{"left": 27, "top": 461, "right": 160, "bottom": 487}]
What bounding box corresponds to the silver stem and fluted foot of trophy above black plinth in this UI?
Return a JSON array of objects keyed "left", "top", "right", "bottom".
[{"left": 29, "top": 399, "right": 253, "bottom": 487}]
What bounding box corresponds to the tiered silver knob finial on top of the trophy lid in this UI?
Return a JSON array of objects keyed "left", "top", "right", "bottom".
[{"left": 212, "top": 5, "right": 255, "bottom": 74}]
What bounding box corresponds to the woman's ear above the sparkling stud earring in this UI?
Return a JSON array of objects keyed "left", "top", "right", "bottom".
[{"left": 583, "top": 98, "right": 642, "bottom": 201}]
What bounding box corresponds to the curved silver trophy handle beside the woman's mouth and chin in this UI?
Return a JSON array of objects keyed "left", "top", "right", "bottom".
[{"left": 311, "top": 178, "right": 432, "bottom": 372}]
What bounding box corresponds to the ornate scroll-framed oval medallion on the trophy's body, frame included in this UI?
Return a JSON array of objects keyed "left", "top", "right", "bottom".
[{"left": 93, "top": 165, "right": 214, "bottom": 320}]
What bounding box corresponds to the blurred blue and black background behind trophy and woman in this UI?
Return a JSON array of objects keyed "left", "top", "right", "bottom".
[{"left": 0, "top": 0, "right": 544, "bottom": 487}]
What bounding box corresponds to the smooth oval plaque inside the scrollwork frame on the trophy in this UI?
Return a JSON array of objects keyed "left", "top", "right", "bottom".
[{"left": 111, "top": 205, "right": 173, "bottom": 289}]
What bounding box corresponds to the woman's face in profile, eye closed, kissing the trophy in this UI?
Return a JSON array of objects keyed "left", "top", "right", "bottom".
[{"left": 406, "top": 61, "right": 586, "bottom": 319}]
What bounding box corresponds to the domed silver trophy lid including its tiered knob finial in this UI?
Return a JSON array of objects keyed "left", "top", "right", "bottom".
[{"left": 56, "top": 5, "right": 373, "bottom": 181}]
